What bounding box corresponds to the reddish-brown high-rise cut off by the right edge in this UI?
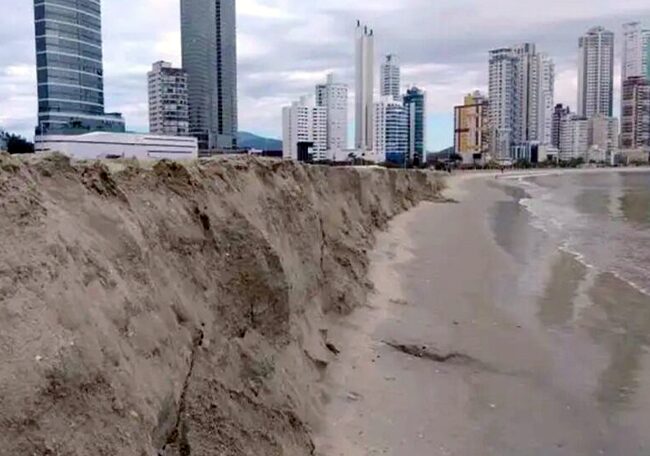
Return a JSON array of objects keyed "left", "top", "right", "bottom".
[{"left": 621, "top": 76, "right": 650, "bottom": 149}]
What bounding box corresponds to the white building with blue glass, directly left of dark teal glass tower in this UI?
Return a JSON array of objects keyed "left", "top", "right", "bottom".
[{"left": 374, "top": 96, "right": 409, "bottom": 164}]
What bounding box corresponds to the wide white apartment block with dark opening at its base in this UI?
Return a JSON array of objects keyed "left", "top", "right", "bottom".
[{"left": 282, "top": 97, "right": 328, "bottom": 161}]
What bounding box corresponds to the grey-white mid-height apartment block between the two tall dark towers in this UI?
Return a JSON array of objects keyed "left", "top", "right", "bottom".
[{"left": 147, "top": 61, "right": 190, "bottom": 136}]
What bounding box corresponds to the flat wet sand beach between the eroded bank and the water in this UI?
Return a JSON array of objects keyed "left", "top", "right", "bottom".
[{"left": 317, "top": 176, "right": 650, "bottom": 456}]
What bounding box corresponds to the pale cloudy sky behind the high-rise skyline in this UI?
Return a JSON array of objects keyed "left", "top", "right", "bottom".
[{"left": 0, "top": 0, "right": 650, "bottom": 151}]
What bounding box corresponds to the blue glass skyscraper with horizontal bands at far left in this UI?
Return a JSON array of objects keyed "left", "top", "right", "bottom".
[{"left": 34, "top": 0, "right": 124, "bottom": 136}]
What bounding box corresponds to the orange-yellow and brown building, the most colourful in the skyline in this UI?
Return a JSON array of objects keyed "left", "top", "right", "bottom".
[{"left": 454, "top": 91, "right": 489, "bottom": 164}]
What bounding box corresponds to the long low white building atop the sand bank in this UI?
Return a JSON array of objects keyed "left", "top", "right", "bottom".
[{"left": 35, "top": 132, "right": 199, "bottom": 160}]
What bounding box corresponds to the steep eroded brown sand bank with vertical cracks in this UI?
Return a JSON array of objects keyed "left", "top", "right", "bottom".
[{"left": 0, "top": 155, "right": 440, "bottom": 456}]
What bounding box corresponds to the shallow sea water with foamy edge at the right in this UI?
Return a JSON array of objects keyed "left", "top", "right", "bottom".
[{"left": 518, "top": 172, "right": 650, "bottom": 295}]
